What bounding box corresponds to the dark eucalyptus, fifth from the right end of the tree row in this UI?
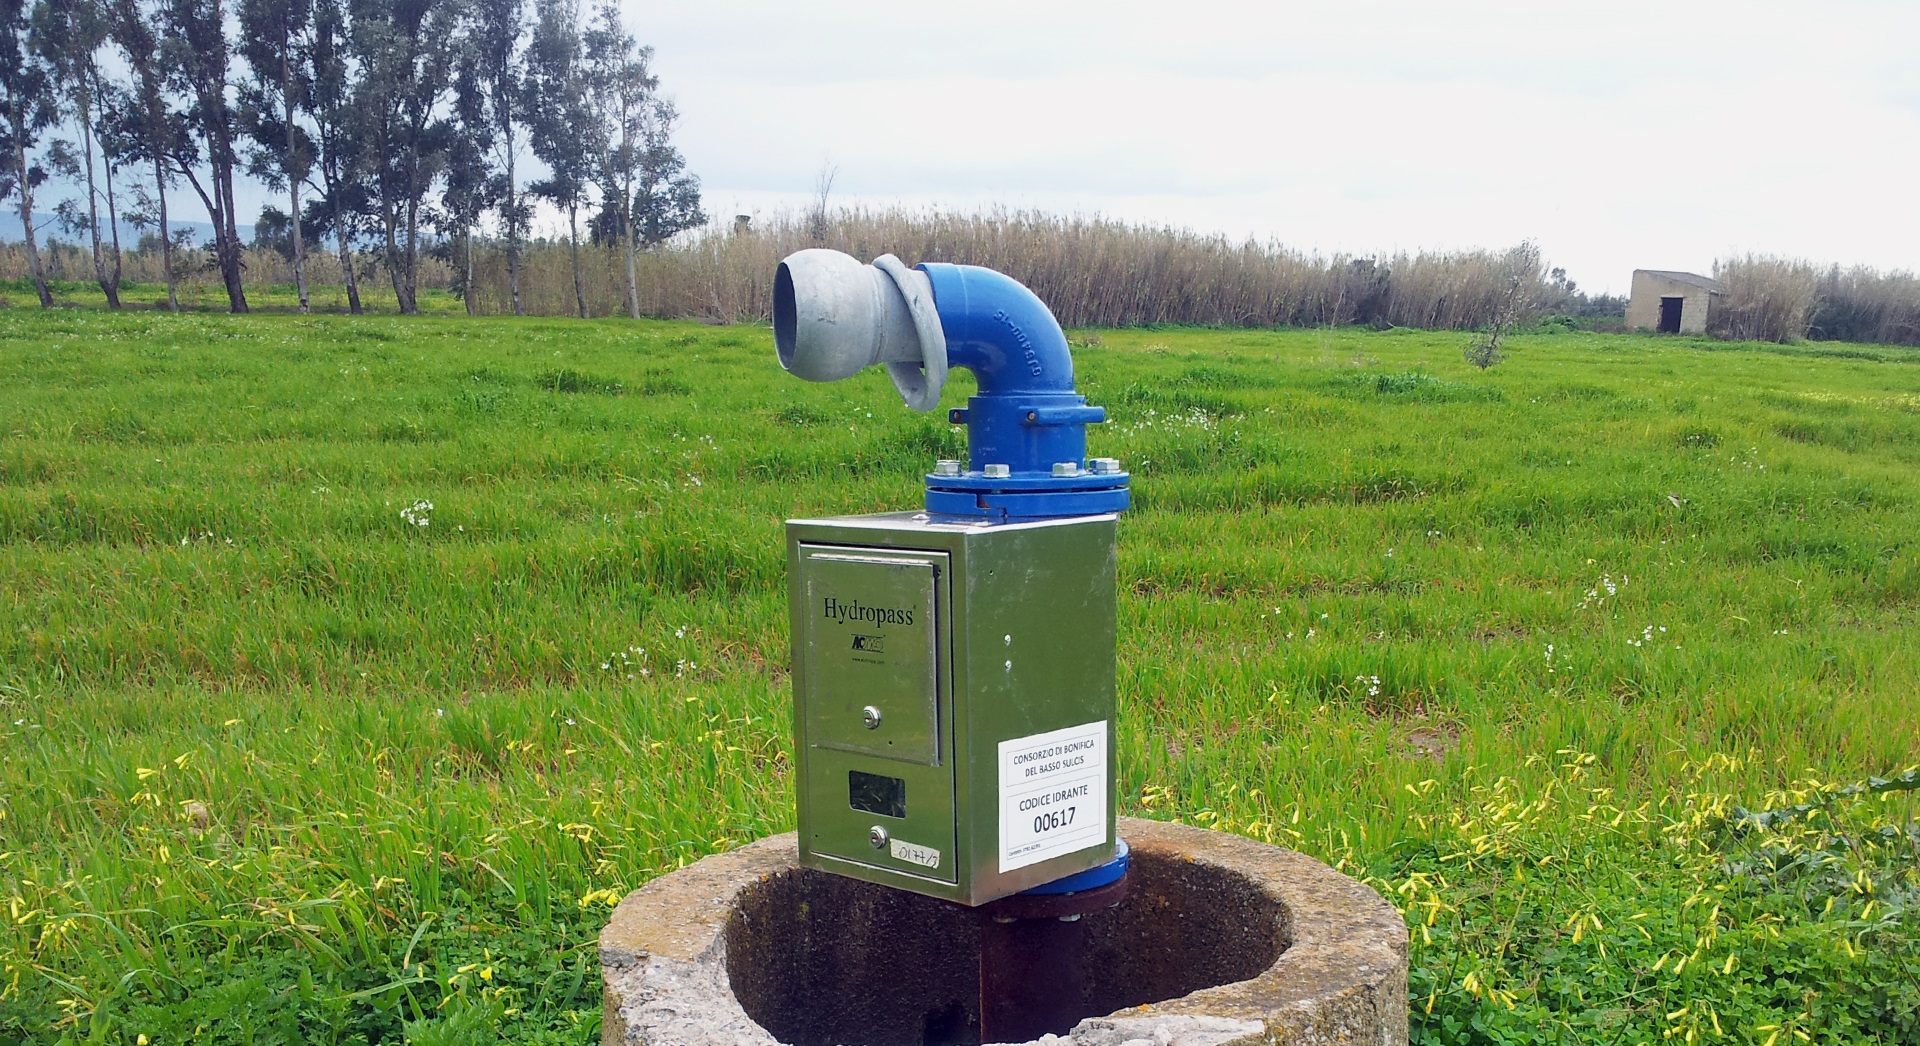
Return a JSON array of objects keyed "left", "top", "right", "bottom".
[{"left": 349, "top": 0, "right": 463, "bottom": 313}]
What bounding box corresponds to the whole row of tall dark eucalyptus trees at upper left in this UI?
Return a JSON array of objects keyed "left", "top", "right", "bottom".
[{"left": 0, "top": 0, "right": 707, "bottom": 315}]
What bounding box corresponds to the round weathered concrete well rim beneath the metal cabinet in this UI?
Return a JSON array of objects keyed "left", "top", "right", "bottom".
[{"left": 601, "top": 818, "right": 1407, "bottom": 1046}]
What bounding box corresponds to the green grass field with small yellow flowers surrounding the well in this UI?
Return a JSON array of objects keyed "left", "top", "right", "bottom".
[{"left": 0, "top": 309, "right": 1920, "bottom": 1046}]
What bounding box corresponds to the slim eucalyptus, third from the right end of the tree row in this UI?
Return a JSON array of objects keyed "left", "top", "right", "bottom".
[{"left": 463, "top": 0, "right": 530, "bottom": 317}]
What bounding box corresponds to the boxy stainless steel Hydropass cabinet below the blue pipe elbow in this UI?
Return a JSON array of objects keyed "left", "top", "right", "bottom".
[{"left": 787, "top": 512, "right": 1116, "bottom": 904}]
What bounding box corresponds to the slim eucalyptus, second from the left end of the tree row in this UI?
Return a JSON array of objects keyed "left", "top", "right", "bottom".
[{"left": 33, "top": 0, "right": 121, "bottom": 309}]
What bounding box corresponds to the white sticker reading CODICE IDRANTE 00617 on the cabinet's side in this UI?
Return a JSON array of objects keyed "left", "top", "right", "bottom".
[{"left": 1000, "top": 720, "right": 1106, "bottom": 871}]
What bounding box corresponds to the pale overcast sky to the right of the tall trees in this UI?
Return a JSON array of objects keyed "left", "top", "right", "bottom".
[{"left": 641, "top": 0, "right": 1920, "bottom": 292}]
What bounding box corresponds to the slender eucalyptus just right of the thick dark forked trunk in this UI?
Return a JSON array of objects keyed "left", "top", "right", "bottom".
[{"left": 240, "top": 0, "right": 313, "bottom": 313}]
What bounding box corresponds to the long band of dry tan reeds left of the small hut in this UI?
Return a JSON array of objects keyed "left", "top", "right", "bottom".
[{"left": 0, "top": 209, "right": 1559, "bottom": 328}]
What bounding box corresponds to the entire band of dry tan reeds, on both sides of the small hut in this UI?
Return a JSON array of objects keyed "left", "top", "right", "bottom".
[{"left": 11, "top": 209, "right": 1920, "bottom": 344}]
